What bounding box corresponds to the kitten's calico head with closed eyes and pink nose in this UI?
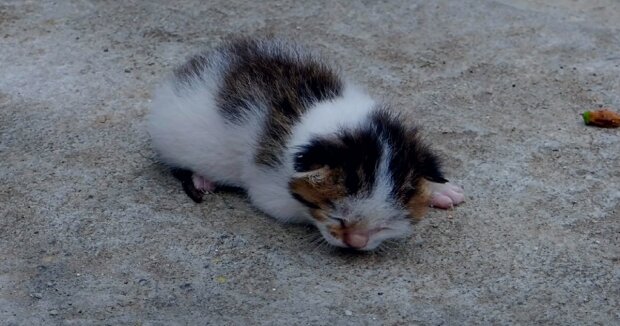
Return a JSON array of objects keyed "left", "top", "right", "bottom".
[{"left": 289, "top": 111, "right": 446, "bottom": 250}]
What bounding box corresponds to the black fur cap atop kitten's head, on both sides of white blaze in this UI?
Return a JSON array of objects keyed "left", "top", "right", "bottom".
[{"left": 295, "top": 108, "right": 447, "bottom": 204}]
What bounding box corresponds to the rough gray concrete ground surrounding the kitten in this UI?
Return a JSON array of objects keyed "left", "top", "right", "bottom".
[{"left": 0, "top": 0, "right": 620, "bottom": 325}]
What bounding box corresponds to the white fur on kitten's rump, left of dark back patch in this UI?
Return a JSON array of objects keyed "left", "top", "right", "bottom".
[{"left": 149, "top": 76, "right": 258, "bottom": 186}]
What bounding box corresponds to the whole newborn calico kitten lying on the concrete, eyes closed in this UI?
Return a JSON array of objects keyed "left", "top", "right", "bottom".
[{"left": 150, "top": 40, "right": 463, "bottom": 249}]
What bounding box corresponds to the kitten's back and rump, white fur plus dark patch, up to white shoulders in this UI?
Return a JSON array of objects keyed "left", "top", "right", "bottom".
[{"left": 149, "top": 39, "right": 344, "bottom": 186}]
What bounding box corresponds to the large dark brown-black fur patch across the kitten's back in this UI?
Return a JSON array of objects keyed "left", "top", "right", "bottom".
[{"left": 217, "top": 40, "right": 343, "bottom": 166}]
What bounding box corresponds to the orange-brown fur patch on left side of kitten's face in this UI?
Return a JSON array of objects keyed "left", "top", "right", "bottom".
[{"left": 289, "top": 167, "right": 346, "bottom": 221}]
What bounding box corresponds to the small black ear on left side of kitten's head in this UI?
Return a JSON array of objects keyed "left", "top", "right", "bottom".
[{"left": 294, "top": 139, "right": 342, "bottom": 172}]
